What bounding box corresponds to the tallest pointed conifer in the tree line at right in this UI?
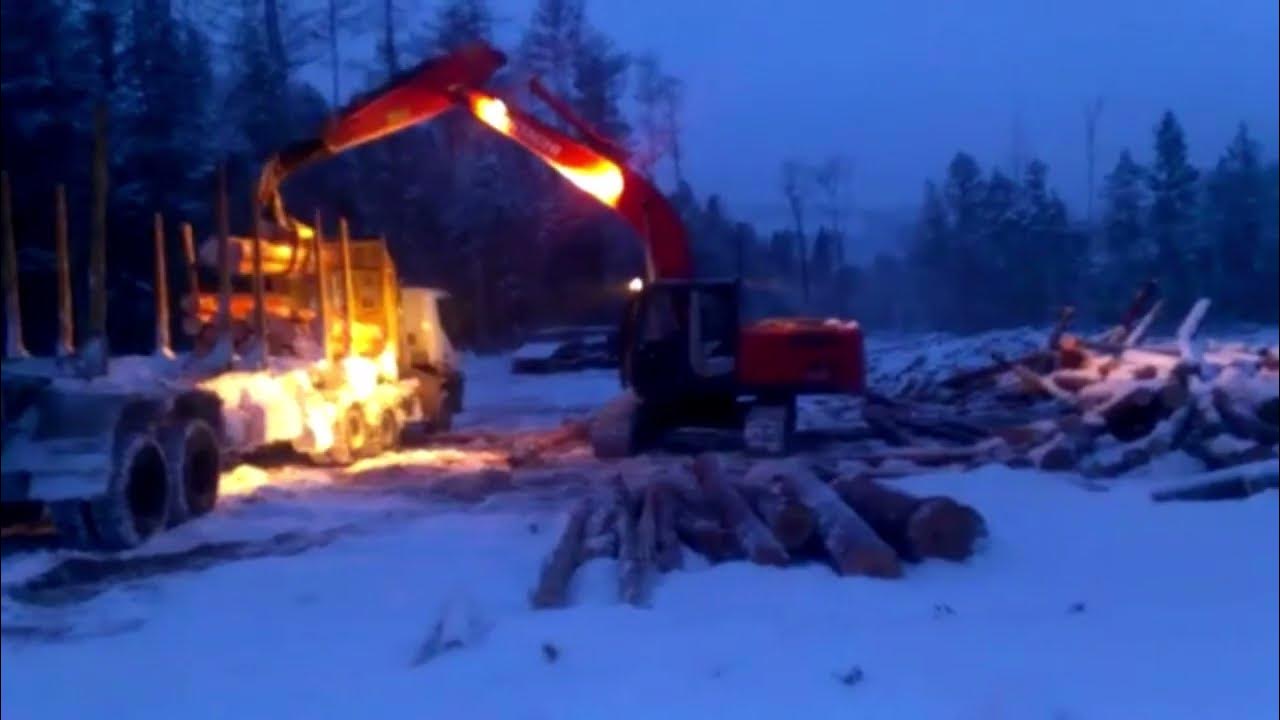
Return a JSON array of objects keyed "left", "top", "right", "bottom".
[{"left": 1147, "top": 111, "right": 1199, "bottom": 306}]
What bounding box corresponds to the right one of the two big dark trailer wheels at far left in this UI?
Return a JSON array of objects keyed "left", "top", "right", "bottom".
[{"left": 160, "top": 419, "right": 221, "bottom": 525}]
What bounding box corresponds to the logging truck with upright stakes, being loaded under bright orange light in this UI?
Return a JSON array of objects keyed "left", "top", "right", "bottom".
[{"left": 0, "top": 162, "right": 462, "bottom": 550}]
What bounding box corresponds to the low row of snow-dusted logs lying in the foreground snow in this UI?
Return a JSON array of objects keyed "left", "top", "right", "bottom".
[{"left": 530, "top": 454, "right": 987, "bottom": 607}]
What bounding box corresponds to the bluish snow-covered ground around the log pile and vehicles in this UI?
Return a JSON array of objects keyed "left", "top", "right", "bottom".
[{"left": 0, "top": 333, "right": 1280, "bottom": 719}]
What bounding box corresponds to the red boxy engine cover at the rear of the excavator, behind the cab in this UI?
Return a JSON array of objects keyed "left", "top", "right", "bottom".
[{"left": 737, "top": 318, "right": 867, "bottom": 393}]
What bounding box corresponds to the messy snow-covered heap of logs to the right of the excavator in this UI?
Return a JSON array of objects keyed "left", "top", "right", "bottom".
[{"left": 838, "top": 285, "right": 1280, "bottom": 486}]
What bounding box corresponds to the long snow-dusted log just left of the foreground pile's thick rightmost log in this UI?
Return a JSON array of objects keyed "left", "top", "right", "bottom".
[{"left": 751, "top": 461, "right": 902, "bottom": 578}]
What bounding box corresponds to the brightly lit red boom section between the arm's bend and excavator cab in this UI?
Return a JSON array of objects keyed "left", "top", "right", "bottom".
[{"left": 462, "top": 88, "right": 694, "bottom": 279}]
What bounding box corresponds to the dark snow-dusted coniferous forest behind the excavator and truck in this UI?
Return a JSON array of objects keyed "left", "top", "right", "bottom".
[{"left": 0, "top": 0, "right": 1280, "bottom": 352}]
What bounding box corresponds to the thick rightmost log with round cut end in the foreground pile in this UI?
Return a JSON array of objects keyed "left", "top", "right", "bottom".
[{"left": 831, "top": 478, "right": 987, "bottom": 562}]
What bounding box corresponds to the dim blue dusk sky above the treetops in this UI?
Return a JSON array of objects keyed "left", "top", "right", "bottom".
[{"left": 312, "top": 0, "right": 1280, "bottom": 227}]
